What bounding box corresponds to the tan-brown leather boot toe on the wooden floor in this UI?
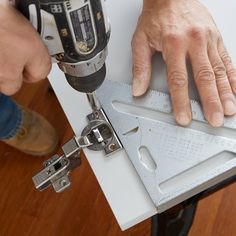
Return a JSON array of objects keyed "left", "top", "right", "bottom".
[{"left": 3, "top": 108, "right": 58, "bottom": 156}]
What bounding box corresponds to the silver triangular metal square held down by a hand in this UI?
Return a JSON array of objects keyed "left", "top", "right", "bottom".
[{"left": 97, "top": 80, "right": 236, "bottom": 212}]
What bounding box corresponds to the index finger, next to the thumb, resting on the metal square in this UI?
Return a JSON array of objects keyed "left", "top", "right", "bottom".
[{"left": 165, "top": 44, "right": 192, "bottom": 126}]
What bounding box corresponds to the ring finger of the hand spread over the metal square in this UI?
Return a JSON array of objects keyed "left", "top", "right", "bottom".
[{"left": 208, "top": 45, "right": 236, "bottom": 115}]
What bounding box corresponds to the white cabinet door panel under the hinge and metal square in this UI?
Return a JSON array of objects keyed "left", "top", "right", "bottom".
[{"left": 49, "top": 0, "right": 236, "bottom": 229}]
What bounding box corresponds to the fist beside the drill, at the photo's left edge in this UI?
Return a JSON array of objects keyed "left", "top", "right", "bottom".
[{"left": 0, "top": 1, "right": 51, "bottom": 95}]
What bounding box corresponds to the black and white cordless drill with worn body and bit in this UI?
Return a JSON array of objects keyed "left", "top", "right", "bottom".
[{"left": 16, "top": 0, "right": 110, "bottom": 107}]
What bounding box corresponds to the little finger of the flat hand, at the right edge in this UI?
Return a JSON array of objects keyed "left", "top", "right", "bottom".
[{"left": 218, "top": 39, "right": 236, "bottom": 93}]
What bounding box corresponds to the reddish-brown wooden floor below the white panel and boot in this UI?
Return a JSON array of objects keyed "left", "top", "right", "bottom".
[{"left": 0, "top": 81, "right": 236, "bottom": 236}]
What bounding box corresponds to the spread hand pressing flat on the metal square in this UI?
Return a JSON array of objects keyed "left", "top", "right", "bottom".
[{"left": 132, "top": 0, "right": 236, "bottom": 127}]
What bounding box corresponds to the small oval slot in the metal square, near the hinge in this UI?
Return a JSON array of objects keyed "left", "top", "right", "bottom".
[{"left": 139, "top": 146, "right": 157, "bottom": 171}]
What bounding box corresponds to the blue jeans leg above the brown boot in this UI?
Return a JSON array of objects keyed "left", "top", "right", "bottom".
[{"left": 0, "top": 93, "right": 22, "bottom": 139}]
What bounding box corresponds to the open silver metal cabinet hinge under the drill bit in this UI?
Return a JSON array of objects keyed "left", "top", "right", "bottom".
[{"left": 32, "top": 109, "right": 122, "bottom": 192}]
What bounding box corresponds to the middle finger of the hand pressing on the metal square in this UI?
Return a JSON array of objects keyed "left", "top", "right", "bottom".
[{"left": 189, "top": 44, "right": 224, "bottom": 127}]
